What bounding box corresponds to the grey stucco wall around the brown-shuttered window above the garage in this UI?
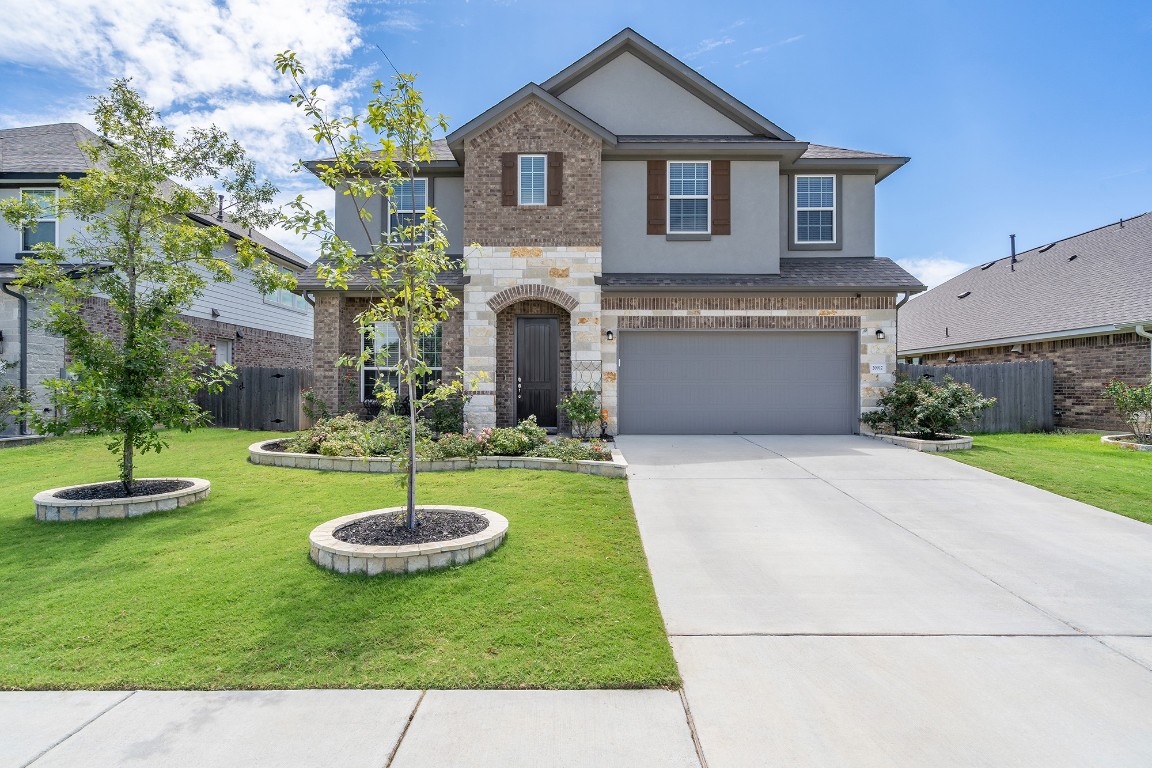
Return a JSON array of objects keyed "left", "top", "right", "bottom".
[{"left": 601, "top": 158, "right": 781, "bottom": 274}]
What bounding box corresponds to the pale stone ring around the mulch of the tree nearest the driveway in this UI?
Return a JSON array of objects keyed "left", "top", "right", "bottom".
[{"left": 308, "top": 504, "right": 508, "bottom": 576}]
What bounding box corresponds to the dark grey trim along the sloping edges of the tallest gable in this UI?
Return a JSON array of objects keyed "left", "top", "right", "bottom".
[{"left": 543, "top": 26, "right": 795, "bottom": 142}]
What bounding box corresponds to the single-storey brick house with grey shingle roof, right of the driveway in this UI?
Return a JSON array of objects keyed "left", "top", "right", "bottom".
[{"left": 900, "top": 213, "right": 1152, "bottom": 429}]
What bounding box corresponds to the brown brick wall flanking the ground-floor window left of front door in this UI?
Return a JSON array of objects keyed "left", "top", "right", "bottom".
[{"left": 312, "top": 291, "right": 464, "bottom": 411}]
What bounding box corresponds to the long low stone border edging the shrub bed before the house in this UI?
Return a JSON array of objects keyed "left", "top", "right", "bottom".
[{"left": 248, "top": 440, "right": 628, "bottom": 478}]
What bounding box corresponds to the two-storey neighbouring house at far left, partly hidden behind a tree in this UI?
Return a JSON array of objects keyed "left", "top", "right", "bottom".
[{"left": 0, "top": 123, "right": 312, "bottom": 431}]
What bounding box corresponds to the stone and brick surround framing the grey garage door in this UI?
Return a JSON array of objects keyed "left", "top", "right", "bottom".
[{"left": 601, "top": 294, "right": 896, "bottom": 432}]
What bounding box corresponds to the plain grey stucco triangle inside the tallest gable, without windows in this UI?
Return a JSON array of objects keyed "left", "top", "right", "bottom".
[{"left": 559, "top": 53, "right": 749, "bottom": 136}]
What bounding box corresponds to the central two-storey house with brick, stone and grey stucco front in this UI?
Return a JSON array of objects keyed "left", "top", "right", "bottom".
[{"left": 300, "top": 29, "right": 924, "bottom": 433}]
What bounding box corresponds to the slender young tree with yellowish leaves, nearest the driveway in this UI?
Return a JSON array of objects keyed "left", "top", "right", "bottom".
[{"left": 275, "top": 51, "right": 463, "bottom": 529}]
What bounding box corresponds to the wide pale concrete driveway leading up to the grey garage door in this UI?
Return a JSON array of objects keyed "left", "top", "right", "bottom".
[{"left": 619, "top": 436, "right": 1152, "bottom": 768}]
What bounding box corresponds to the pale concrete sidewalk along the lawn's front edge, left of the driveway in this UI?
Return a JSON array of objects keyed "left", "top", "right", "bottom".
[{"left": 0, "top": 691, "right": 699, "bottom": 768}]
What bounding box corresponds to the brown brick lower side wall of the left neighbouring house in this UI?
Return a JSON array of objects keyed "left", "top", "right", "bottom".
[{"left": 74, "top": 297, "right": 312, "bottom": 368}]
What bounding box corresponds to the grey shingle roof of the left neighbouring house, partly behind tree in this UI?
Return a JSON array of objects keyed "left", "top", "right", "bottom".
[{"left": 0, "top": 123, "right": 309, "bottom": 269}]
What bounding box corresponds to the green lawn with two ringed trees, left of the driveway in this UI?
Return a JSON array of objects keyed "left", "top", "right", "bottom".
[{"left": 0, "top": 429, "right": 680, "bottom": 689}]
